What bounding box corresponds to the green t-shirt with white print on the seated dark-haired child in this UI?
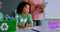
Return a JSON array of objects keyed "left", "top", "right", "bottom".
[{"left": 17, "top": 14, "right": 33, "bottom": 25}]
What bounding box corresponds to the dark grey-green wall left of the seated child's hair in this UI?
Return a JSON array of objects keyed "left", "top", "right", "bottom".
[{"left": 1, "top": 0, "right": 23, "bottom": 16}]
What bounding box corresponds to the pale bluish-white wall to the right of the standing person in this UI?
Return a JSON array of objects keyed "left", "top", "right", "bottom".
[{"left": 45, "top": 0, "right": 60, "bottom": 19}]
